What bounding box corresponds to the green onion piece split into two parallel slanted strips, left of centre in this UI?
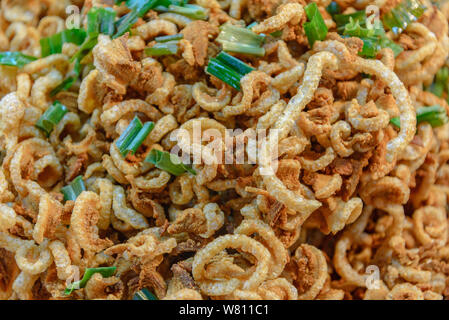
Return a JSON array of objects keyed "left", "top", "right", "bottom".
[{"left": 116, "top": 117, "right": 154, "bottom": 157}]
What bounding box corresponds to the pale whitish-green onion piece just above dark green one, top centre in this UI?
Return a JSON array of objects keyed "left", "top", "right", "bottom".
[{"left": 217, "top": 24, "right": 265, "bottom": 57}]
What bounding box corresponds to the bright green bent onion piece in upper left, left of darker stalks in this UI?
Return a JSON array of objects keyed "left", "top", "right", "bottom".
[{"left": 40, "top": 29, "right": 86, "bottom": 57}]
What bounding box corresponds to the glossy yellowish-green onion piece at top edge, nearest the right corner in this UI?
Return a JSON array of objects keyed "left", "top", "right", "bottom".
[{"left": 382, "top": 0, "right": 426, "bottom": 34}]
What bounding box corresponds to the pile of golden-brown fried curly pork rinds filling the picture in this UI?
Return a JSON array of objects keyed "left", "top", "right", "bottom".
[{"left": 0, "top": 0, "right": 449, "bottom": 300}]
